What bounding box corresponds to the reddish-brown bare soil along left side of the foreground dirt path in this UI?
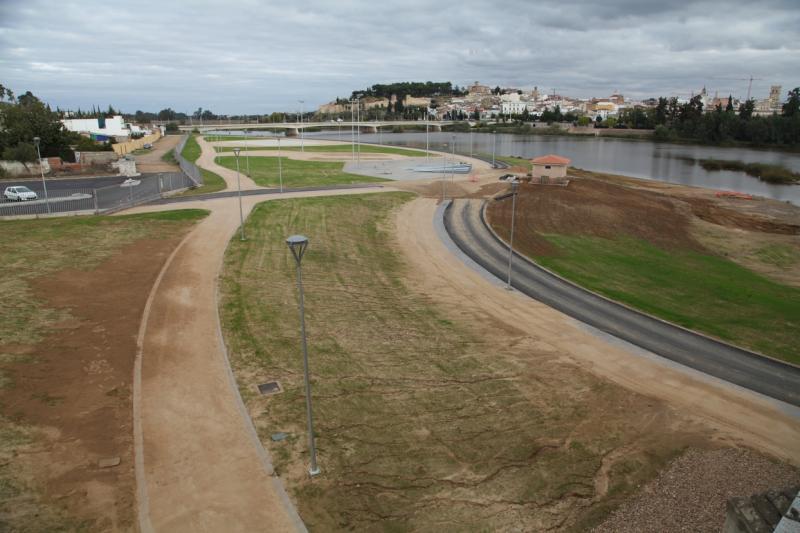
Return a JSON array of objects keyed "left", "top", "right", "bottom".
[{"left": 0, "top": 237, "right": 184, "bottom": 530}]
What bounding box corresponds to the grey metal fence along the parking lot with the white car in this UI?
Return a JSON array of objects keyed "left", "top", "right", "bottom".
[{"left": 0, "top": 172, "right": 196, "bottom": 217}]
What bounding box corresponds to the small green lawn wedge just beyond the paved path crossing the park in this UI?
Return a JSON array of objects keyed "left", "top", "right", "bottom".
[{"left": 217, "top": 156, "right": 388, "bottom": 187}]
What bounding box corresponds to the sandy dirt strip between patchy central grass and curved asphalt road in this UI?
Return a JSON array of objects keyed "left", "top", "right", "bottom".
[{"left": 396, "top": 199, "right": 800, "bottom": 464}]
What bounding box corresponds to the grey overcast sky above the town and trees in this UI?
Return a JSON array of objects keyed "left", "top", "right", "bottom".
[{"left": 0, "top": 0, "right": 800, "bottom": 114}]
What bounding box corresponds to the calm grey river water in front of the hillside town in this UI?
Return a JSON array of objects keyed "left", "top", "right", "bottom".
[{"left": 306, "top": 128, "right": 800, "bottom": 205}]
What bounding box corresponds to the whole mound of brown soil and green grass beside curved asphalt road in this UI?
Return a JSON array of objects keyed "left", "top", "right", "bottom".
[{"left": 488, "top": 180, "right": 800, "bottom": 364}]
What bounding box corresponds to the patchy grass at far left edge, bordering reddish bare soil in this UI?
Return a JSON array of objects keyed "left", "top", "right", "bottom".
[{"left": 0, "top": 210, "right": 207, "bottom": 531}]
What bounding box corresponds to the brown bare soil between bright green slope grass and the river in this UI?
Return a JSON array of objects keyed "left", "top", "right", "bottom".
[{"left": 484, "top": 171, "right": 800, "bottom": 285}]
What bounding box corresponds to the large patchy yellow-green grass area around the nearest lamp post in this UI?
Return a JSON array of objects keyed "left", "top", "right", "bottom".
[{"left": 221, "top": 193, "right": 692, "bottom": 531}]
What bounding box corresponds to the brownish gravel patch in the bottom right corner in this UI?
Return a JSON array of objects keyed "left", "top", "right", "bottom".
[{"left": 594, "top": 448, "right": 800, "bottom": 533}]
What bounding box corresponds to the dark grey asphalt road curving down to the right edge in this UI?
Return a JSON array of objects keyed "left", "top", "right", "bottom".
[{"left": 444, "top": 200, "right": 800, "bottom": 406}]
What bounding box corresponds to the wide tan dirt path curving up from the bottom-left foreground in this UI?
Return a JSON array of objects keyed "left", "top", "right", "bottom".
[{"left": 127, "top": 130, "right": 400, "bottom": 532}]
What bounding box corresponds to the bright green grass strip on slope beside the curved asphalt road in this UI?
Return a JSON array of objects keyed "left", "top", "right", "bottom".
[{"left": 536, "top": 235, "right": 800, "bottom": 364}]
